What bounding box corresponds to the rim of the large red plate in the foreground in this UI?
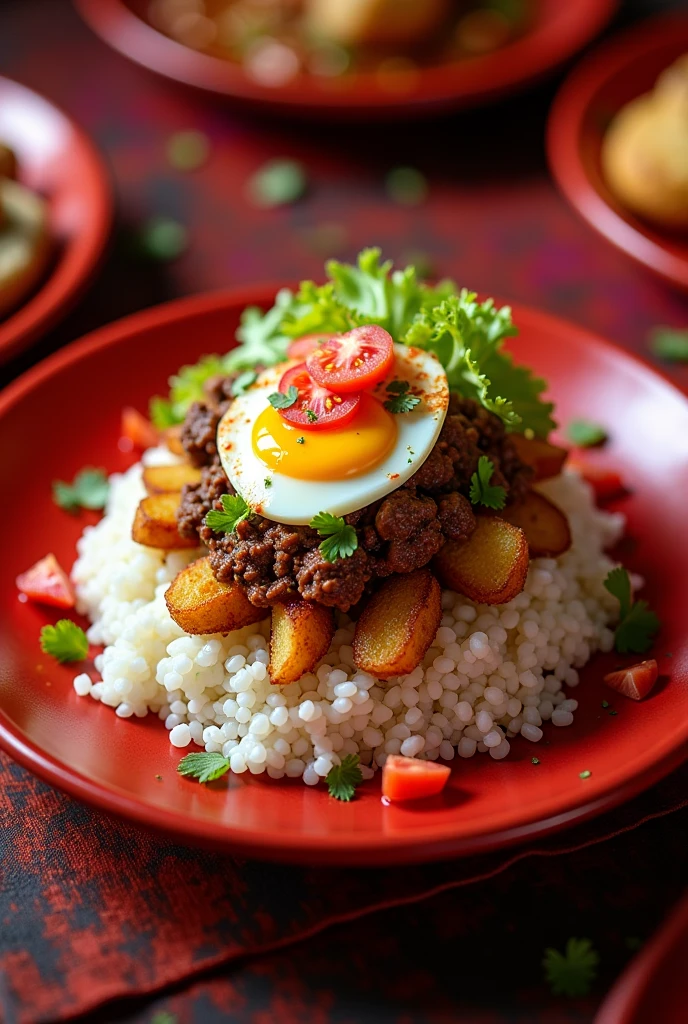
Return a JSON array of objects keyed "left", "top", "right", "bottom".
[{"left": 0, "top": 285, "right": 688, "bottom": 864}]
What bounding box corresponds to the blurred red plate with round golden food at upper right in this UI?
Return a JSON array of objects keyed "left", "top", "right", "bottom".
[{"left": 547, "top": 15, "right": 688, "bottom": 288}]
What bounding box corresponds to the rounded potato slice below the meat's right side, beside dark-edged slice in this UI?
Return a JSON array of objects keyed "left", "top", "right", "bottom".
[{"left": 433, "top": 516, "right": 529, "bottom": 604}]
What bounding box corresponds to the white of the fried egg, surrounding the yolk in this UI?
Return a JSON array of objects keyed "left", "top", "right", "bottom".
[{"left": 217, "top": 345, "right": 449, "bottom": 525}]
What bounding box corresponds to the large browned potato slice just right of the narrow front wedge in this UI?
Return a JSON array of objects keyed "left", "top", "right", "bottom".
[{"left": 353, "top": 569, "right": 442, "bottom": 679}]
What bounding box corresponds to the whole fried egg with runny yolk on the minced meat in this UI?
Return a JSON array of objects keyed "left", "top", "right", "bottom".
[{"left": 217, "top": 345, "right": 449, "bottom": 525}]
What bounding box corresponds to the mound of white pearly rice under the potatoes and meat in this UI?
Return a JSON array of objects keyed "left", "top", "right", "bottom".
[{"left": 73, "top": 450, "right": 624, "bottom": 785}]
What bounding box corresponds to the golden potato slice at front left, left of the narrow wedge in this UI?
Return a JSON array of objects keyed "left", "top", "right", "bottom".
[{"left": 165, "top": 558, "right": 266, "bottom": 636}]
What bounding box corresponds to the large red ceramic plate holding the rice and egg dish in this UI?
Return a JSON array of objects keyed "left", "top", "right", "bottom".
[{"left": 0, "top": 289, "right": 688, "bottom": 863}]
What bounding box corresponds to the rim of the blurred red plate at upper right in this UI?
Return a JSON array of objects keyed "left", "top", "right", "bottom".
[{"left": 546, "top": 14, "right": 688, "bottom": 289}]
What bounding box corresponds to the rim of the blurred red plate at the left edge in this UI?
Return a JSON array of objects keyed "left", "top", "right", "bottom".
[{"left": 0, "top": 77, "right": 113, "bottom": 362}]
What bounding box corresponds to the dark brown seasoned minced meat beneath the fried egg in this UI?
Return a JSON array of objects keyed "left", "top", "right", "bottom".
[{"left": 178, "top": 379, "right": 530, "bottom": 611}]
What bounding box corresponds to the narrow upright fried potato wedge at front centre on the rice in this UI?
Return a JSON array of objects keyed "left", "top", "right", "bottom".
[{"left": 269, "top": 600, "right": 335, "bottom": 686}]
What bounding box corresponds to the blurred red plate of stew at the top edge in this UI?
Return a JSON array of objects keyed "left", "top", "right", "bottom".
[{"left": 75, "top": 0, "right": 616, "bottom": 118}]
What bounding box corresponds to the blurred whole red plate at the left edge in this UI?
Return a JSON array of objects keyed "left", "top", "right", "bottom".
[{"left": 0, "top": 78, "right": 112, "bottom": 362}]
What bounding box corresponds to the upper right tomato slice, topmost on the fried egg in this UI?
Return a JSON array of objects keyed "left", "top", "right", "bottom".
[{"left": 306, "top": 324, "right": 394, "bottom": 393}]
